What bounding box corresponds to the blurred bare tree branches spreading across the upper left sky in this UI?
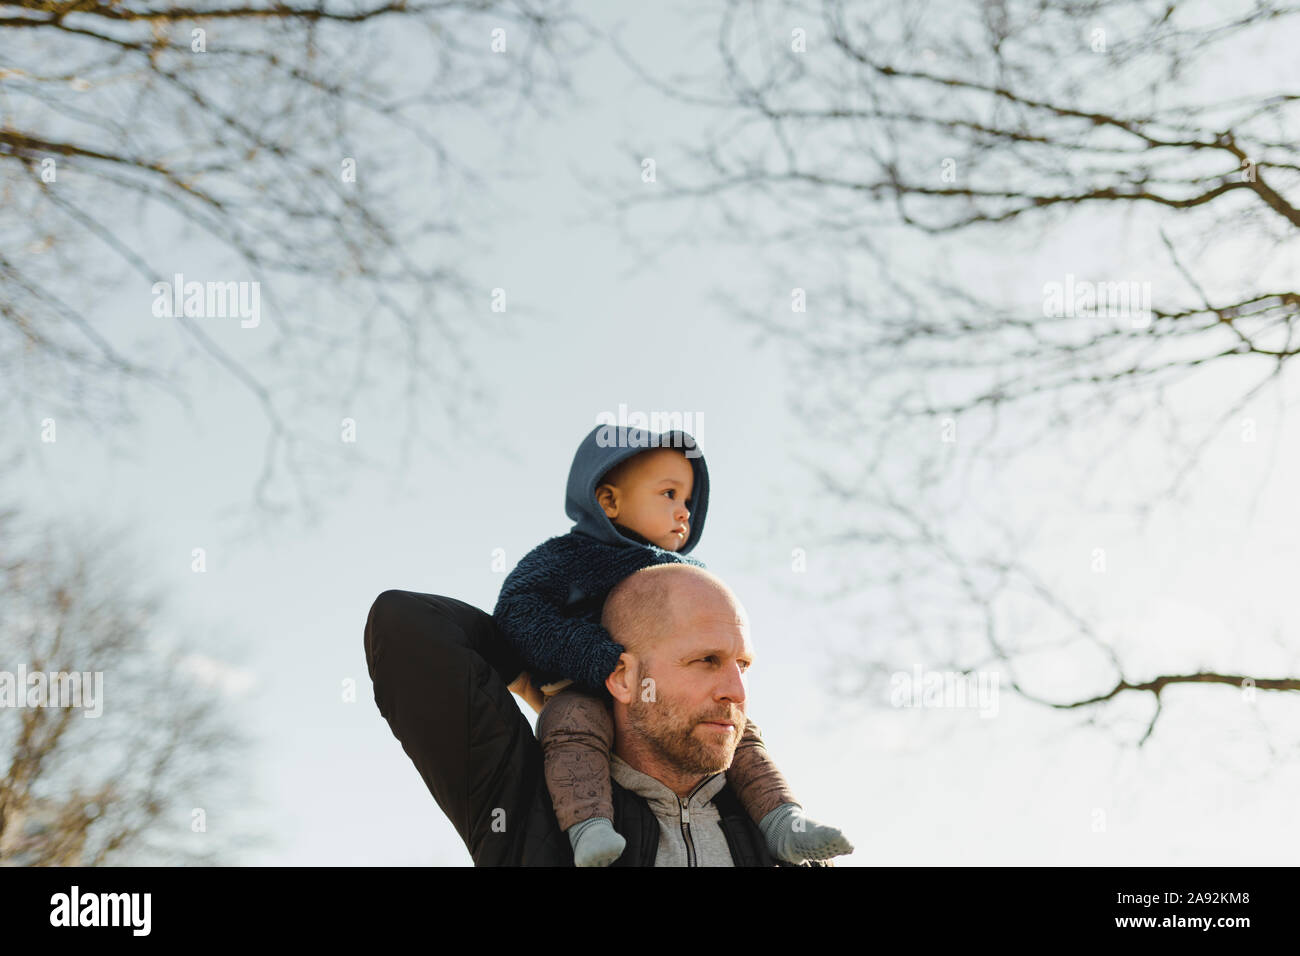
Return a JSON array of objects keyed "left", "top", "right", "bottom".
[{"left": 0, "top": 0, "right": 584, "bottom": 522}]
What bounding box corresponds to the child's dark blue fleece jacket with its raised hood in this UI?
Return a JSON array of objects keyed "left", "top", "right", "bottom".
[{"left": 493, "top": 425, "right": 709, "bottom": 696}]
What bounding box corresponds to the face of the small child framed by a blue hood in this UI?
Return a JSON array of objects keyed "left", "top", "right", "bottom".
[{"left": 595, "top": 449, "right": 696, "bottom": 551}]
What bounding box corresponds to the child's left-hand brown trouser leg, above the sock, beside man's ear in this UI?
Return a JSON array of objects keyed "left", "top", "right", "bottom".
[{"left": 537, "top": 687, "right": 614, "bottom": 830}]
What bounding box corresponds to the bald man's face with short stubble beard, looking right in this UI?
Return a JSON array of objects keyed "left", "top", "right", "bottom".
[{"left": 627, "top": 601, "right": 754, "bottom": 774}]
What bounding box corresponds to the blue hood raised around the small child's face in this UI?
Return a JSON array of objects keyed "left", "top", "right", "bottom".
[{"left": 564, "top": 425, "right": 709, "bottom": 554}]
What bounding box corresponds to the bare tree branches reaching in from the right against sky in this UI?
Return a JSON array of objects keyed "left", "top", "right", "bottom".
[{"left": 593, "top": 0, "right": 1300, "bottom": 741}]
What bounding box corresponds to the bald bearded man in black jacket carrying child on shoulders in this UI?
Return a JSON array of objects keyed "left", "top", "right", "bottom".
[{"left": 365, "top": 563, "right": 831, "bottom": 866}]
